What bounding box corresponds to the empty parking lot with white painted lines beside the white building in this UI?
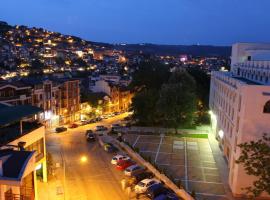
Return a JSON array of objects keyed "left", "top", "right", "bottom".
[{"left": 123, "top": 134, "right": 227, "bottom": 200}]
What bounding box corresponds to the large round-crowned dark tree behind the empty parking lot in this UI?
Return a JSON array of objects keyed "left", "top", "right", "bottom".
[{"left": 157, "top": 70, "right": 196, "bottom": 129}]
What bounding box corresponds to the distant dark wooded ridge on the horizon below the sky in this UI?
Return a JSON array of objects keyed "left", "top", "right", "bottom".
[{"left": 115, "top": 44, "right": 231, "bottom": 57}]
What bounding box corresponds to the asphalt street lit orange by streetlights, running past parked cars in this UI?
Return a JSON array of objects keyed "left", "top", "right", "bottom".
[{"left": 46, "top": 113, "right": 128, "bottom": 200}]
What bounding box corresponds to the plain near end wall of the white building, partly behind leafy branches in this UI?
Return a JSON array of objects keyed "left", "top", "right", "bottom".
[{"left": 230, "top": 86, "right": 270, "bottom": 198}]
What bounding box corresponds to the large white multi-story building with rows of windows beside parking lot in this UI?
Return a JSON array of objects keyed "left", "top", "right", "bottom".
[{"left": 209, "top": 43, "right": 270, "bottom": 197}]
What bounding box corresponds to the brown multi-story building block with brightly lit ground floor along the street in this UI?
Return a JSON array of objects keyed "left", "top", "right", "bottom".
[{"left": 0, "top": 78, "right": 80, "bottom": 127}]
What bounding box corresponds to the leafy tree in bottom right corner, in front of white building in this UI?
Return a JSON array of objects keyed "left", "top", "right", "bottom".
[{"left": 236, "top": 134, "right": 270, "bottom": 197}]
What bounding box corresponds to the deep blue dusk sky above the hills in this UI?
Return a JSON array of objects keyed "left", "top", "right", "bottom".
[{"left": 0, "top": 0, "right": 270, "bottom": 45}]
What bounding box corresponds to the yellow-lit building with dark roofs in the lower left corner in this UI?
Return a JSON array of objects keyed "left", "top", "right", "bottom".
[{"left": 0, "top": 105, "right": 47, "bottom": 199}]
